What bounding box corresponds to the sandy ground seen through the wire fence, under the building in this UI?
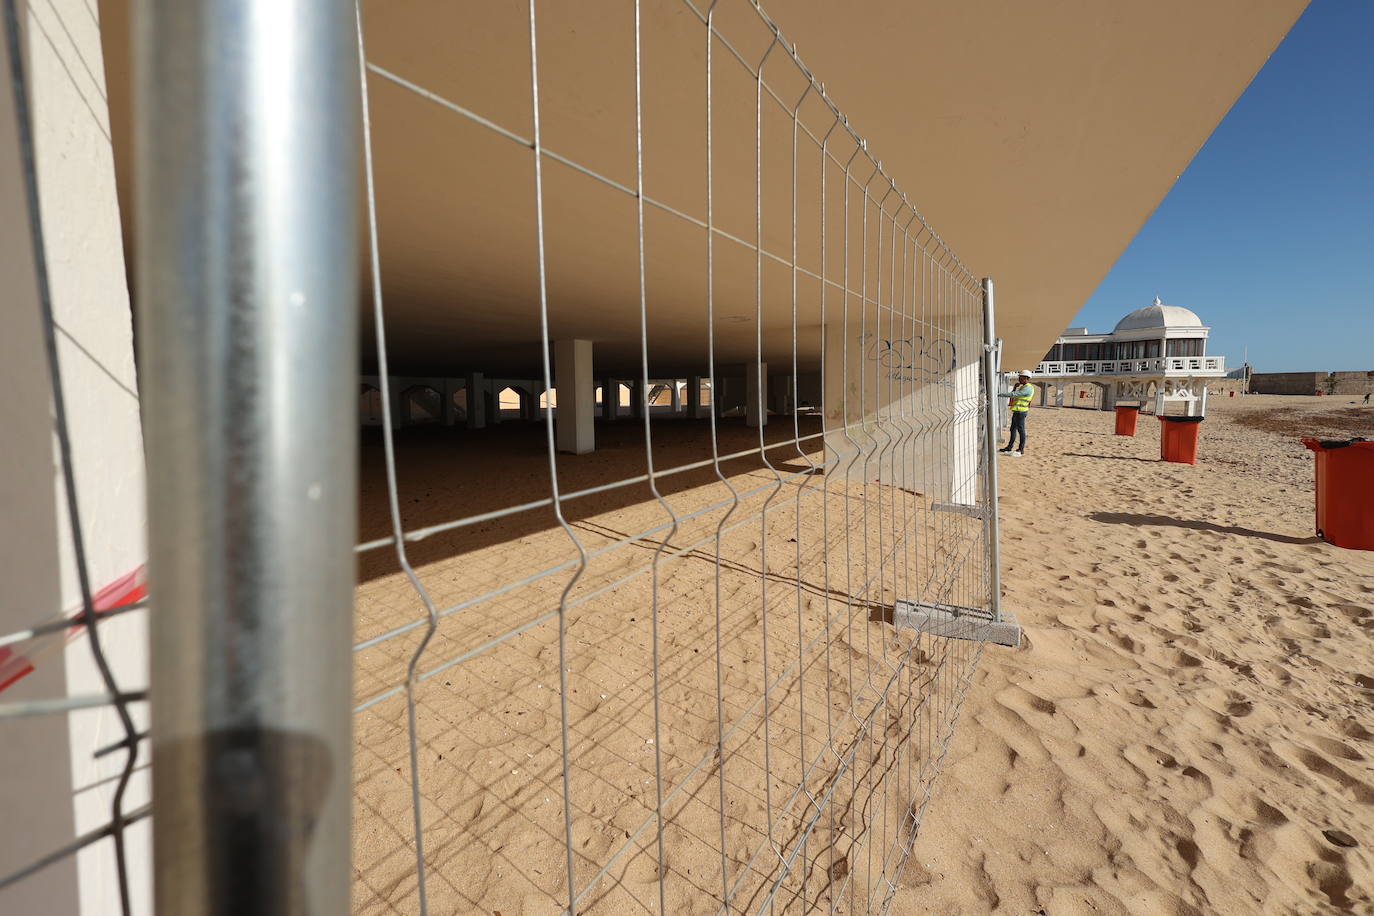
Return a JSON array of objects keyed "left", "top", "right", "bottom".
[{"left": 353, "top": 417, "right": 988, "bottom": 916}]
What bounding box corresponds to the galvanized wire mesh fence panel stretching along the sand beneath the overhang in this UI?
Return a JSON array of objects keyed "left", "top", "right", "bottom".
[{"left": 354, "top": 0, "right": 991, "bottom": 913}]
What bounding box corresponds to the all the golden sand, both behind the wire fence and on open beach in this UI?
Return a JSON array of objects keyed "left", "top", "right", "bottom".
[{"left": 346, "top": 397, "right": 1374, "bottom": 916}]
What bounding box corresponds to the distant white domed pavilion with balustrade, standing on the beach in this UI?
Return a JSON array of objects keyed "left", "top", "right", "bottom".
[{"left": 1036, "top": 298, "right": 1226, "bottom": 416}]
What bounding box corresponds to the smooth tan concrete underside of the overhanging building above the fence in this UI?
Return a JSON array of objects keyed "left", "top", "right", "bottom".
[{"left": 91, "top": 0, "right": 1305, "bottom": 376}]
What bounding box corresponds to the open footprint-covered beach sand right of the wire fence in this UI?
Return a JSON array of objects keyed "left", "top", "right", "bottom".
[{"left": 893, "top": 396, "right": 1374, "bottom": 916}]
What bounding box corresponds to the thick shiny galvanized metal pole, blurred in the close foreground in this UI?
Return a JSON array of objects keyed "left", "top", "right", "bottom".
[{"left": 133, "top": 0, "right": 359, "bottom": 916}]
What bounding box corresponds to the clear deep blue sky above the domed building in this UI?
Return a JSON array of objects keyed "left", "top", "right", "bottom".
[{"left": 1073, "top": 0, "right": 1374, "bottom": 372}]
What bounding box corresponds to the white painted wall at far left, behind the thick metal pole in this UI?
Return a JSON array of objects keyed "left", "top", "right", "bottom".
[{"left": 0, "top": 0, "right": 151, "bottom": 916}]
